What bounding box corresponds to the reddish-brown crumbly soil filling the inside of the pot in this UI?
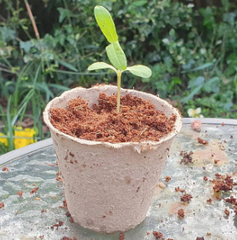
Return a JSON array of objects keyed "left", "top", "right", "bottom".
[{"left": 50, "top": 93, "right": 176, "bottom": 143}]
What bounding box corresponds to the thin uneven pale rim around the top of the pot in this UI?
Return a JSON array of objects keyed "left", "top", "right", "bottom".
[{"left": 43, "top": 84, "right": 182, "bottom": 148}]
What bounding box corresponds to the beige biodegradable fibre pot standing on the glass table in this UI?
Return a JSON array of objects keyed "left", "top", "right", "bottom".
[{"left": 44, "top": 85, "right": 182, "bottom": 233}]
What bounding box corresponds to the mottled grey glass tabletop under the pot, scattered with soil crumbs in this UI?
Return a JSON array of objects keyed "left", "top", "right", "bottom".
[{"left": 0, "top": 119, "right": 237, "bottom": 240}]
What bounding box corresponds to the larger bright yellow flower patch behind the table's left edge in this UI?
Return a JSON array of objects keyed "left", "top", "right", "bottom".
[{"left": 14, "top": 127, "right": 37, "bottom": 149}]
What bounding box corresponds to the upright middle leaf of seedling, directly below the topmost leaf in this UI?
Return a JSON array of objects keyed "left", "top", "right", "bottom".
[{"left": 106, "top": 42, "right": 127, "bottom": 70}]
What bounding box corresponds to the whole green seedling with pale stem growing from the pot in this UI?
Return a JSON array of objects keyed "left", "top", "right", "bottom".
[{"left": 88, "top": 6, "right": 152, "bottom": 113}]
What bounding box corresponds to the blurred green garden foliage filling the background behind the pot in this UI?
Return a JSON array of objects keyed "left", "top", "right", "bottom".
[{"left": 0, "top": 0, "right": 237, "bottom": 153}]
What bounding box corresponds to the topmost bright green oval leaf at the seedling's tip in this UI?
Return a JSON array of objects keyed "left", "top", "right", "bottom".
[{"left": 94, "top": 6, "right": 118, "bottom": 43}]
